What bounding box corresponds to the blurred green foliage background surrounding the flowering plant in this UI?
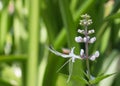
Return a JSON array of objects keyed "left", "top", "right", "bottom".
[{"left": 0, "top": 0, "right": 120, "bottom": 86}]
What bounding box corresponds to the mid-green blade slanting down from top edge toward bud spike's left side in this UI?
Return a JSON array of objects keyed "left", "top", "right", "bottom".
[{"left": 59, "top": 0, "right": 78, "bottom": 47}]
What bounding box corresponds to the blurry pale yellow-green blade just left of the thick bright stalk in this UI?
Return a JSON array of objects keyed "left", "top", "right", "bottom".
[{"left": 13, "top": 0, "right": 27, "bottom": 53}]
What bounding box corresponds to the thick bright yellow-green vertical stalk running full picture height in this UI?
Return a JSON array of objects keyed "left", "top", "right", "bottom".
[{"left": 26, "top": 0, "right": 40, "bottom": 86}]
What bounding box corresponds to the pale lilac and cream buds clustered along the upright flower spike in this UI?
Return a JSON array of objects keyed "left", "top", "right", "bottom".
[{"left": 75, "top": 14, "right": 99, "bottom": 61}]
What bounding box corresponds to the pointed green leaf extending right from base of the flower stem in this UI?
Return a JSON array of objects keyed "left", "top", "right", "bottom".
[{"left": 89, "top": 73, "right": 116, "bottom": 84}]
